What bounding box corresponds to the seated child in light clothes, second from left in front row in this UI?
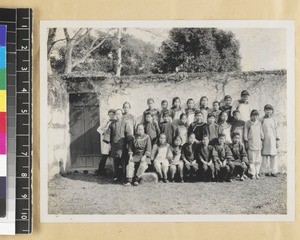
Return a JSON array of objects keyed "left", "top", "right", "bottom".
[{"left": 151, "top": 133, "right": 173, "bottom": 183}]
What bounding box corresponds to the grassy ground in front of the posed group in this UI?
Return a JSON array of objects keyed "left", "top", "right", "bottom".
[{"left": 49, "top": 173, "right": 287, "bottom": 214}]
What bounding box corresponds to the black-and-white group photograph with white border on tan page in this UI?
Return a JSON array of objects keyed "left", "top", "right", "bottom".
[{"left": 40, "top": 21, "right": 295, "bottom": 222}]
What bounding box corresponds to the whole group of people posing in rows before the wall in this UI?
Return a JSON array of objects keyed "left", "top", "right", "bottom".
[{"left": 98, "top": 90, "right": 279, "bottom": 186}]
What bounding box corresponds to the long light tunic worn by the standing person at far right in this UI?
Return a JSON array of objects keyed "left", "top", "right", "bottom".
[{"left": 261, "top": 117, "right": 279, "bottom": 156}]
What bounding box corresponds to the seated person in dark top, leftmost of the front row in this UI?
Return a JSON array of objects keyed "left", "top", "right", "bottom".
[{"left": 125, "top": 124, "right": 151, "bottom": 186}]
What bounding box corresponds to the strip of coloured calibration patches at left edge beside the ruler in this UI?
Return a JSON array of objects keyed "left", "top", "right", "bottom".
[{"left": 0, "top": 25, "right": 7, "bottom": 218}]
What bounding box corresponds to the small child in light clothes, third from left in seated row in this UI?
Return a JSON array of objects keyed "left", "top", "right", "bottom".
[{"left": 170, "top": 136, "right": 184, "bottom": 183}]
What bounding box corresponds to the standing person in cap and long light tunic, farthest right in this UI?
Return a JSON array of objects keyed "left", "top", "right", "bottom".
[{"left": 261, "top": 104, "right": 279, "bottom": 177}]
